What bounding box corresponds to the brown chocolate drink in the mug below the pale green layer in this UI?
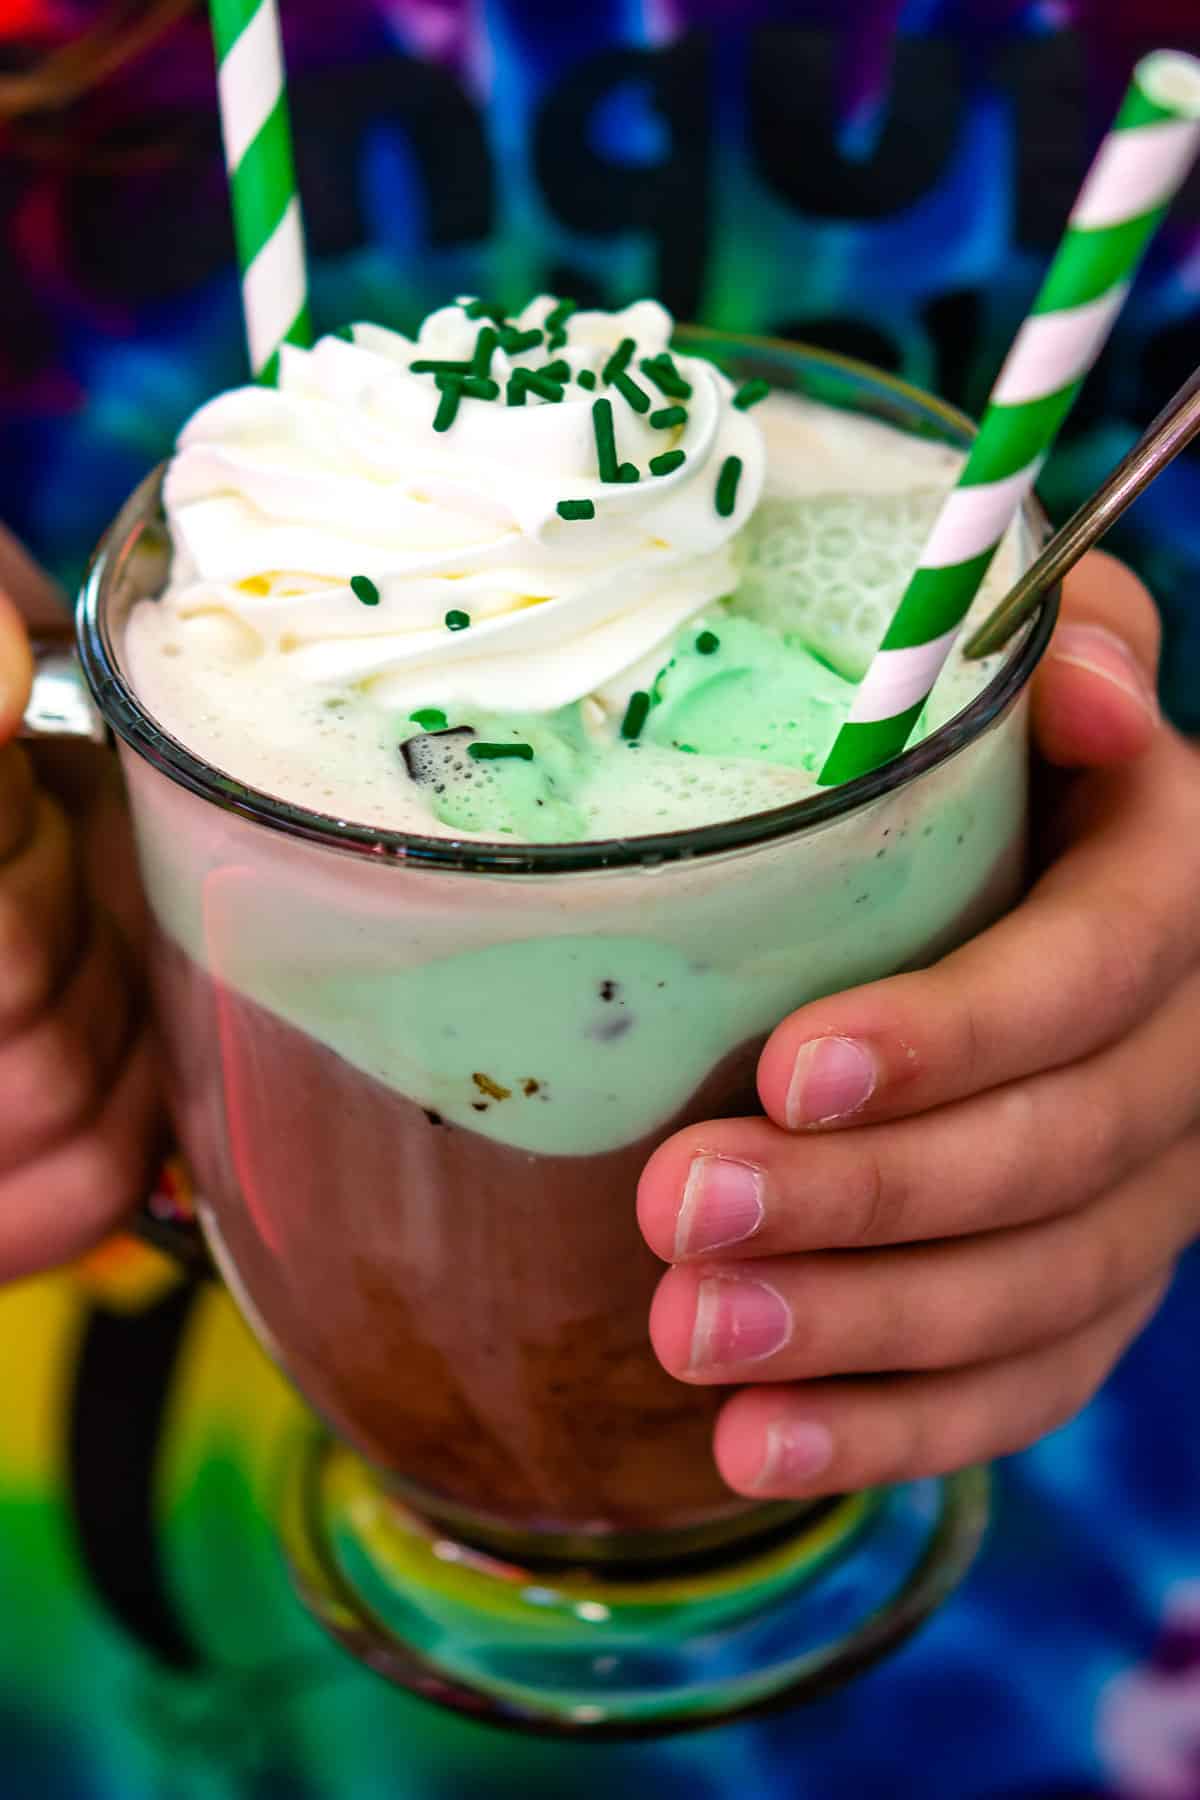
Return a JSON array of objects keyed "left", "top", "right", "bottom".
[{"left": 153, "top": 932, "right": 770, "bottom": 1534}]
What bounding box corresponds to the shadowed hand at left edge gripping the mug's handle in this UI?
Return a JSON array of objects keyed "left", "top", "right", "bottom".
[{"left": 0, "top": 540, "right": 158, "bottom": 1283}]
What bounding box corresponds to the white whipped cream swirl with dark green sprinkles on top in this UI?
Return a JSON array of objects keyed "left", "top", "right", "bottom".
[{"left": 162, "top": 295, "right": 765, "bottom": 711}]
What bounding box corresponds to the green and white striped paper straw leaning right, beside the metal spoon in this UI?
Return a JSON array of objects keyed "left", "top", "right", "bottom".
[{"left": 819, "top": 50, "right": 1200, "bottom": 787}]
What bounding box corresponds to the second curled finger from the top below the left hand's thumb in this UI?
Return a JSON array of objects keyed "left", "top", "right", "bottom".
[{"left": 0, "top": 794, "right": 83, "bottom": 1042}]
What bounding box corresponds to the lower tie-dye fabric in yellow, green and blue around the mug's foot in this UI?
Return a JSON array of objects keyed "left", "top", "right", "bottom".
[{"left": 0, "top": 1246, "right": 1200, "bottom": 1800}]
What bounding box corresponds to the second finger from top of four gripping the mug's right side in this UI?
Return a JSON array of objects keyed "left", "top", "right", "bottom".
[{"left": 639, "top": 974, "right": 1200, "bottom": 1262}]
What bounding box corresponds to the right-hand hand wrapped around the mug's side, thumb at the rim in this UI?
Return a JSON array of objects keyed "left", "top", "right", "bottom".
[{"left": 639, "top": 556, "right": 1200, "bottom": 1498}]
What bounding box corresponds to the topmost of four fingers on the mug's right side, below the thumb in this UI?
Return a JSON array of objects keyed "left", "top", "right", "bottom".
[{"left": 759, "top": 733, "right": 1200, "bottom": 1130}]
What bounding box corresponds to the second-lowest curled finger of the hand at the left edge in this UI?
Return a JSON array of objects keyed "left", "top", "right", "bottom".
[{"left": 0, "top": 914, "right": 135, "bottom": 1174}]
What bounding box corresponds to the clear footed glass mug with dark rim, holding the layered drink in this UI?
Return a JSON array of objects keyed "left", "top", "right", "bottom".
[{"left": 53, "top": 333, "right": 1054, "bottom": 1733}]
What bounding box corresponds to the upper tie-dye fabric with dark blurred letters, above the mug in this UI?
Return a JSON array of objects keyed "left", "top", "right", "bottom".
[{"left": 0, "top": 0, "right": 1200, "bottom": 724}]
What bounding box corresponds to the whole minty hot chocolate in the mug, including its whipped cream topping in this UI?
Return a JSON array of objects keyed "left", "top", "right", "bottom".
[{"left": 112, "top": 302, "right": 1025, "bottom": 1555}]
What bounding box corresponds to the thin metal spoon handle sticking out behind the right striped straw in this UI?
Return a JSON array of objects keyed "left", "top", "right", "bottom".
[{"left": 963, "top": 369, "right": 1200, "bottom": 657}]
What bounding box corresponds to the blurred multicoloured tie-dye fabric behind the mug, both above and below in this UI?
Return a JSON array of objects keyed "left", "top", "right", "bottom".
[{"left": 0, "top": 0, "right": 1200, "bottom": 1800}]
